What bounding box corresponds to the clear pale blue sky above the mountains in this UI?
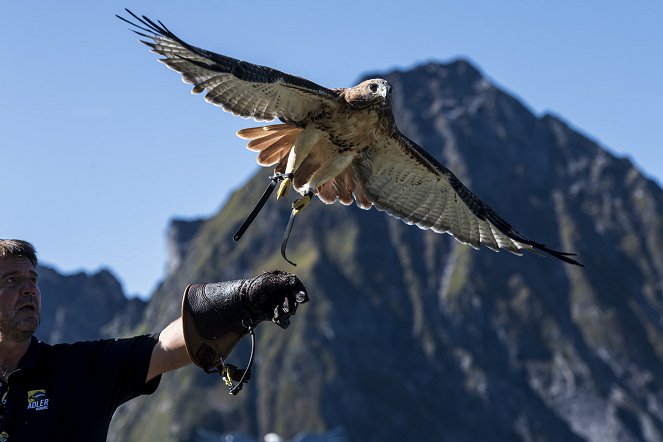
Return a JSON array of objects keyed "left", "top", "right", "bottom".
[{"left": 0, "top": 0, "right": 663, "bottom": 296}]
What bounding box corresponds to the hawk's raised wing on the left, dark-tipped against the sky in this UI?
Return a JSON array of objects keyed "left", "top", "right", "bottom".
[{"left": 117, "top": 9, "right": 339, "bottom": 123}]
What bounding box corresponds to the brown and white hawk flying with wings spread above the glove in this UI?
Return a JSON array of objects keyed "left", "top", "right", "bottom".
[{"left": 118, "top": 10, "right": 581, "bottom": 265}]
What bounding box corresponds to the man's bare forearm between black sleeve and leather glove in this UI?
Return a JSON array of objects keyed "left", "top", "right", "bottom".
[{"left": 145, "top": 317, "right": 191, "bottom": 382}]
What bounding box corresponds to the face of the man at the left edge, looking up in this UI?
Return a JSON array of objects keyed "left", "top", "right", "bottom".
[{"left": 0, "top": 257, "right": 41, "bottom": 342}]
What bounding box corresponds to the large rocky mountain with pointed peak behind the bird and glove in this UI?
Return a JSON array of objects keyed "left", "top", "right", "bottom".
[{"left": 107, "top": 60, "right": 663, "bottom": 442}]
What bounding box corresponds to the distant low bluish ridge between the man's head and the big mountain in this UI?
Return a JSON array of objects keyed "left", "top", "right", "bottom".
[{"left": 35, "top": 265, "right": 146, "bottom": 344}]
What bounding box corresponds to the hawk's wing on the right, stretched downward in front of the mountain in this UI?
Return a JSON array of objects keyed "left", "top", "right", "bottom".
[{"left": 353, "top": 130, "right": 581, "bottom": 265}]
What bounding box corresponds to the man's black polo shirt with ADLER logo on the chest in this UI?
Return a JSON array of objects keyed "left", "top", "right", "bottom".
[{"left": 0, "top": 335, "right": 161, "bottom": 442}]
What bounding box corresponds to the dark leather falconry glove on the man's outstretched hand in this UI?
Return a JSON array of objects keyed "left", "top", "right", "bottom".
[{"left": 182, "top": 270, "right": 309, "bottom": 371}]
